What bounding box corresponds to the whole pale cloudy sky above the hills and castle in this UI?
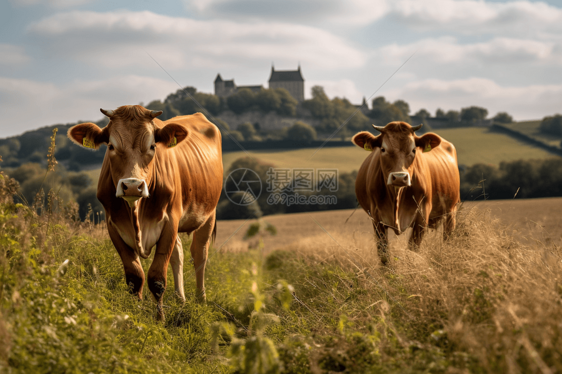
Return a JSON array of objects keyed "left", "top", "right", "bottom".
[{"left": 0, "top": 0, "right": 562, "bottom": 138}]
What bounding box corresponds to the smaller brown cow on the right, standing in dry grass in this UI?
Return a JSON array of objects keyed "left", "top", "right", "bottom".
[{"left": 352, "top": 122, "right": 460, "bottom": 263}]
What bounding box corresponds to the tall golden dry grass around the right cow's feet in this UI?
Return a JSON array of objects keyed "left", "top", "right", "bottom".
[{"left": 280, "top": 209, "right": 562, "bottom": 373}]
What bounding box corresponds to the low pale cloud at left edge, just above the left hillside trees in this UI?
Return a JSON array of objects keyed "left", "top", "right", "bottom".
[{"left": 0, "top": 75, "right": 178, "bottom": 136}]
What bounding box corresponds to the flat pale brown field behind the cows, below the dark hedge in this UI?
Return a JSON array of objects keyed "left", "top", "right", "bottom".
[{"left": 216, "top": 197, "right": 562, "bottom": 250}]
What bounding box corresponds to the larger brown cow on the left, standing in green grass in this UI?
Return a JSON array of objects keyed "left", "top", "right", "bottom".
[{"left": 68, "top": 105, "right": 223, "bottom": 319}]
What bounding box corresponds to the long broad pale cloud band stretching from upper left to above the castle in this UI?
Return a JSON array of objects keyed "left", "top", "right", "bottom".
[{"left": 28, "top": 11, "right": 365, "bottom": 70}]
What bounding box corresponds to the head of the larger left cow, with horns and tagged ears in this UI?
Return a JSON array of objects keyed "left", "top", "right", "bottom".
[{"left": 68, "top": 105, "right": 187, "bottom": 207}]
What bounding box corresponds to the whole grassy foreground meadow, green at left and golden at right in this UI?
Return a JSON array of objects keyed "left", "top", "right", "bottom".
[{"left": 0, "top": 166, "right": 562, "bottom": 373}]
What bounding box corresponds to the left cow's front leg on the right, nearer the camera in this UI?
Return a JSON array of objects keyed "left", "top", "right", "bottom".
[{"left": 148, "top": 220, "right": 178, "bottom": 321}]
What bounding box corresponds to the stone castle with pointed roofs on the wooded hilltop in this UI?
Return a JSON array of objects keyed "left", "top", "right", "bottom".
[{"left": 215, "top": 65, "right": 304, "bottom": 103}]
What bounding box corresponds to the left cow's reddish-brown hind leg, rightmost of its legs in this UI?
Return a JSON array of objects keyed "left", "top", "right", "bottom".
[{"left": 190, "top": 213, "right": 216, "bottom": 303}]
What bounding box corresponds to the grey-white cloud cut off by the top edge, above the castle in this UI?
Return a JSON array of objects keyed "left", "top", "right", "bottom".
[{"left": 184, "top": 0, "right": 389, "bottom": 25}]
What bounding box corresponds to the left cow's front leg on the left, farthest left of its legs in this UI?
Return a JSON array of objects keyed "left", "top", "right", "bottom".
[{"left": 107, "top": 222, "right": 144, "bottom": 300}]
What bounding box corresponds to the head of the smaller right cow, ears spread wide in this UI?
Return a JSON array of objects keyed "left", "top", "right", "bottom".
[{"left": 351, "top": 121, "right": 441, "bottom": 188}]
